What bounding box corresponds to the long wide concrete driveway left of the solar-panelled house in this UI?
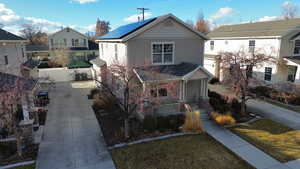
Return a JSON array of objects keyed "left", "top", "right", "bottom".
[{"left": 37, "top": 82, "right": 115, "bottom": 169}]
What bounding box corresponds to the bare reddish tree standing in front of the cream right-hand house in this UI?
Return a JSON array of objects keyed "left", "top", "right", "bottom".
[{"left": 218, "top": 49, "right": 277, "bottom": 117}]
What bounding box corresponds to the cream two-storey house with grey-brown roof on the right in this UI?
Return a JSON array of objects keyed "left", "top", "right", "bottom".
[{"left": 204, "top": 19, "right": 300, "bottom": 83}]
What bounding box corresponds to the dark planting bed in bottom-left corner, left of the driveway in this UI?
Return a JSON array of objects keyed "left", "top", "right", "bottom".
[{"left": 0, "top": 142, "right": 39, "bottom": 166}]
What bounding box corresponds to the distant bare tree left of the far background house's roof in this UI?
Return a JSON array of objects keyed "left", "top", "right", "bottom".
[{"left": 20, "top": 24, "right": 48, "bottom": 45}]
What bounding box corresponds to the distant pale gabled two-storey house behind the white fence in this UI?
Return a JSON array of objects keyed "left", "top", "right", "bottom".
[{"left": 48, "top": 27, "right": 98, "bottom": 61}]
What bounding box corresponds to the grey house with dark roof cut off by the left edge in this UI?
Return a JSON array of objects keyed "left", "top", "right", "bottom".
[{"left": 0, "top": 29, "right": 27, "bottom": 76}]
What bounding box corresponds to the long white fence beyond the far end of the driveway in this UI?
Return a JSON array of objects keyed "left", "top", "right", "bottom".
[{"left": 39, "top": 68, "right": 92, "bottom": 82}]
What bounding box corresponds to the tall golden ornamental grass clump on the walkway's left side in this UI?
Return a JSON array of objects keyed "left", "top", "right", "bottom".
[{"left": 182, "top": 111, "right": 203, "bottom": 133}]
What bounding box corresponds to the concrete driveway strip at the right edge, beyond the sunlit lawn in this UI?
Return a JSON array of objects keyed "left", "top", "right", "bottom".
[{"left": 247, "top": 100, "right": 300, "bottom": 130}]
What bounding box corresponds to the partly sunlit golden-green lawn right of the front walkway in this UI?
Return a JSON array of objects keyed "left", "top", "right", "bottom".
[{"left": 231, "top": 119, "right": 300, "bottom": 162}]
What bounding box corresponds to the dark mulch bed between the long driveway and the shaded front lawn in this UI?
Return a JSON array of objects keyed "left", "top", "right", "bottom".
[{"left": 93, "top": 106, "right": 183, "bottom": 146}]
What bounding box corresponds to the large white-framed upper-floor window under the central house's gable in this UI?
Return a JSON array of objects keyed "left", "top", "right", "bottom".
[{"left": 152, "top": 42, "right": 174, "bottom": 64}]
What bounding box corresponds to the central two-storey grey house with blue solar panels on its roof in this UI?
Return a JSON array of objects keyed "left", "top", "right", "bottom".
[{"left": 96, "top": 14, "right": 212, "bottom": 113}]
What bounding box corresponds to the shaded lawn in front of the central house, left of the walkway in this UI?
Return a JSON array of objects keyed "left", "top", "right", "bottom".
[{"left": 111, "top": 134, "right": 253, "bottom": 169}]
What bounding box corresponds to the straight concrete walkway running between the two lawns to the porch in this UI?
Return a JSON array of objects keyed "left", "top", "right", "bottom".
[{"left": 201, "top": 113, "right": 300, "bottom": 169}]
